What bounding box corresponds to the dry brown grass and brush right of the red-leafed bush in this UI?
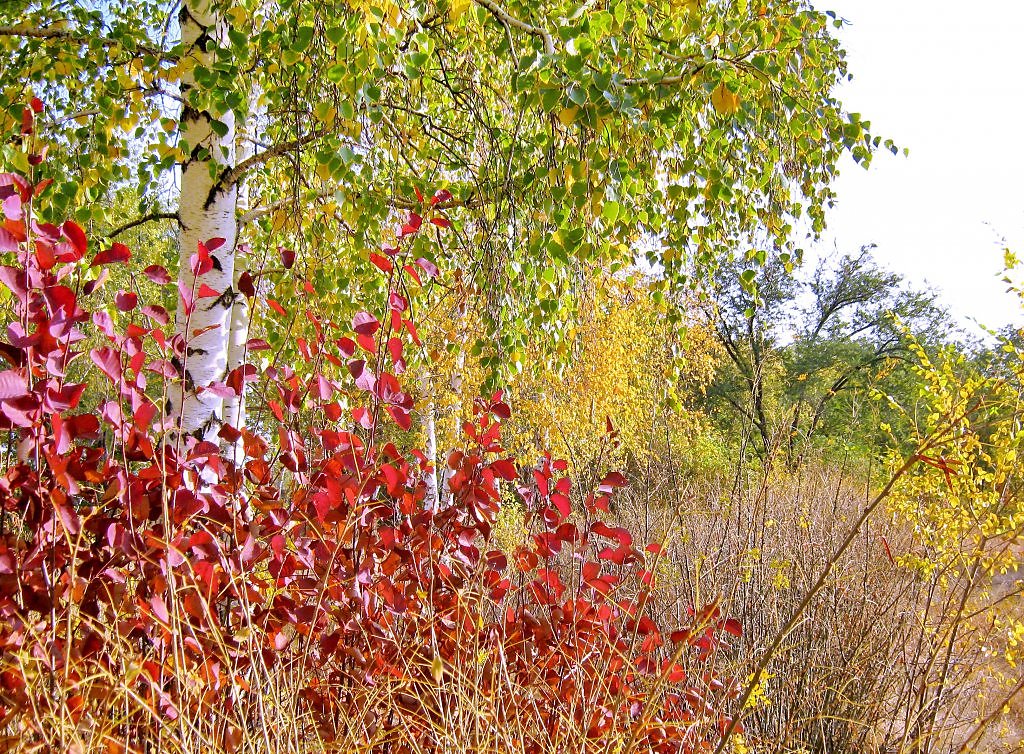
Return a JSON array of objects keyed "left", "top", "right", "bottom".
[{"left": 620, "top": 456, "right": 1024, "bottom": 754}]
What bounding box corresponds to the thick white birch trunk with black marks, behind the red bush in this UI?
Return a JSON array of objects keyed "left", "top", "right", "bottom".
[{"left": 171, "top": 0, "right": 238, "bottom": 442}]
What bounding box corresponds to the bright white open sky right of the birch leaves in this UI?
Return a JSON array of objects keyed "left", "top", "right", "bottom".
[{"left": 815, "top": 0, "right": 1024, "bottom": 328}]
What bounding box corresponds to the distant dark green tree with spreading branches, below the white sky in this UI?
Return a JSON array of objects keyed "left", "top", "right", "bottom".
[{"left": 702, "top": 247, "right": 953, "bottom": 466}]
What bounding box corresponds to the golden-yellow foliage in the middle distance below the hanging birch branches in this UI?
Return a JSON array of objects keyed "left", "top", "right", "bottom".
[{"left": 413, "top": 279, "right": 717, "bottom": 477}]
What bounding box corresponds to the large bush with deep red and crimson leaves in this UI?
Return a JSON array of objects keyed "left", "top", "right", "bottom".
[{"left": 0, "top": 109, "right": 738, "bottom": 752}]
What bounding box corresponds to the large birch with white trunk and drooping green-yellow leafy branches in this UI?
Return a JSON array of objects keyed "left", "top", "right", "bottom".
[{"left": 0, "top": 0, "right": 894, "bottom": 438}]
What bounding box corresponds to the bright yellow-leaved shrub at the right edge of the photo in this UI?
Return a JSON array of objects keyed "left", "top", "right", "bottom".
[{"left": 890, "top": 329, "right": 1024, "bottom": 667}]
